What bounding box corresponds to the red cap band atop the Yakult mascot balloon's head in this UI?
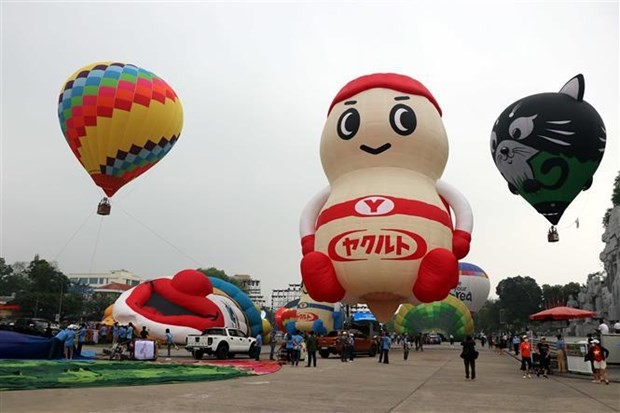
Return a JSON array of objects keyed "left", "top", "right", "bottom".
[{"left": 327, "top": 73, "right": 441, "bottom": 116}]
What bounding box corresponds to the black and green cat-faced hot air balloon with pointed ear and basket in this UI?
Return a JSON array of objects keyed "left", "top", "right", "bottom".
[{"left": 491, "top": 74, "right": 606, "bottom": 242}]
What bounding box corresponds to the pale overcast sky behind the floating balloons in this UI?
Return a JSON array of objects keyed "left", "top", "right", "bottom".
[{"left": 0, "top": 0, "right": 620, "bottom": 302}]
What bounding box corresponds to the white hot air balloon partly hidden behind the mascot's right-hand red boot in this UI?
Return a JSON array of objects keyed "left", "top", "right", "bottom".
[{"left": 450, "top": 262, "right": 491, "bottom": 313}]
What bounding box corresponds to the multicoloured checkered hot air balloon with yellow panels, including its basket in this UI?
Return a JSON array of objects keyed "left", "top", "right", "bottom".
[{"left": 58, "top": 62, "right": 183, "bottom": 215}]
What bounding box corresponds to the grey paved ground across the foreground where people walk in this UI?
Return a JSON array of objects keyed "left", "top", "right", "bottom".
[{"left": 0, "top": 344, "right": 620, "bottom": 413}]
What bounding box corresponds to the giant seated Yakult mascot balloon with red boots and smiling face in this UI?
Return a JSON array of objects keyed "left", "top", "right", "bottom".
[{"left": 300, "top": 73, "right": 473, "bottom": 321}]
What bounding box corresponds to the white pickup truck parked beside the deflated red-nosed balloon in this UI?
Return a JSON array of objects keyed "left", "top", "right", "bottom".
[{"left": 185, "top": 327, "right": 256, "bottom": 360}]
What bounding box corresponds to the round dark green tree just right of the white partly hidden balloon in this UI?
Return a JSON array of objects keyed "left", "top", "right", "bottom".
[{"left": 495, "top": 275, "right": 542, "bottom": 328}]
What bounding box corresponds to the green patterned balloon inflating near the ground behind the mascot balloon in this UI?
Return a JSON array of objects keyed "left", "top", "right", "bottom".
[{"left": 394, "top": 295, "right": 474, "bottom": 340}]
